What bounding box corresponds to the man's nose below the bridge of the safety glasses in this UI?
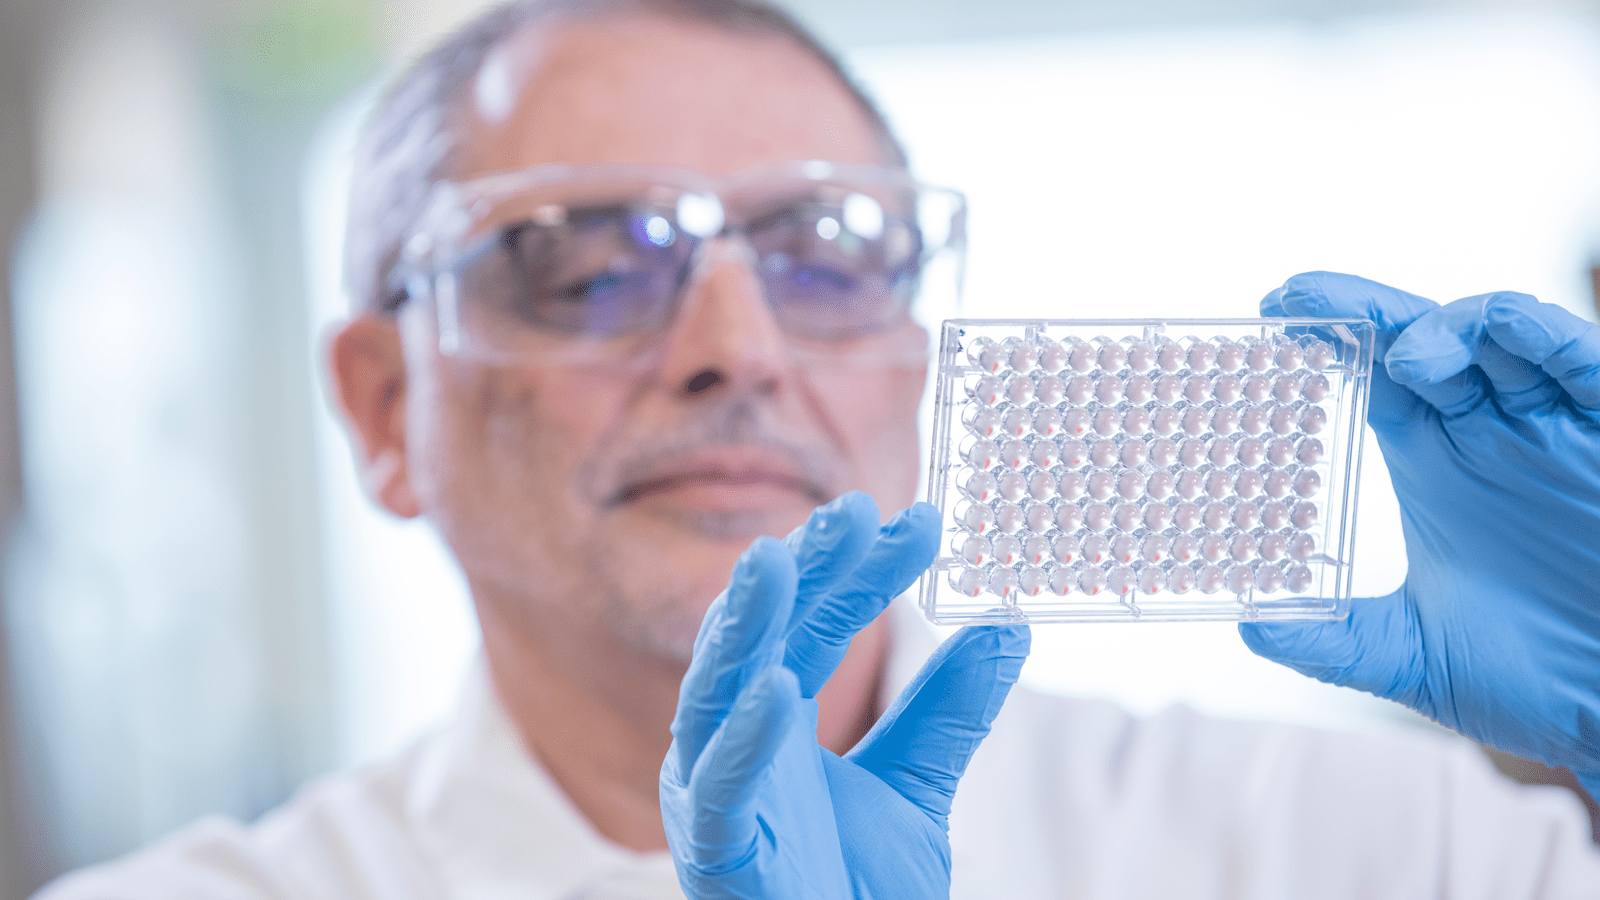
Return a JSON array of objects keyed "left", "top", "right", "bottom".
[{"left": 661, "top": 239, "right": 792, "bottom": 399}]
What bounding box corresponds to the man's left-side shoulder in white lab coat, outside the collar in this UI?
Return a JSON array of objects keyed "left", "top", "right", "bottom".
[{"left": 38, "top": 743, "right": 438, "bottom": 900}]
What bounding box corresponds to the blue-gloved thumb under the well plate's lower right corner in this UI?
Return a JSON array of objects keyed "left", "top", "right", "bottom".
[{"left": 1238, "top": 588, "right": 1427, "bottom": 713}]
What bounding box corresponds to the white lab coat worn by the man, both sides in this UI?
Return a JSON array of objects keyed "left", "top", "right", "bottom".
[{"left": 45, "top": 598, "right": 1600, "bottom": 900}]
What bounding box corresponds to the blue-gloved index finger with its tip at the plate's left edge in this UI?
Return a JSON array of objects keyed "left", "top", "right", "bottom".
[{"left": 784, "top": 503, "right": 939, "bottom": 698}]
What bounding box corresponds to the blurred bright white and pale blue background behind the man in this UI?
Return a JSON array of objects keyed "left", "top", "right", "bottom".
[{"left": 0, "top": 0, "right": 1600, "bottom": 900}]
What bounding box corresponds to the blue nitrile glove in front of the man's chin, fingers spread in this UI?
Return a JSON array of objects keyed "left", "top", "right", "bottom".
[{"left": 661, "top": 493, "right": 1029, "bottom": 900}]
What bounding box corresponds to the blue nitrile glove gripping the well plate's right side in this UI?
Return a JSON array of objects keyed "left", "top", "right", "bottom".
[{"left": 1240, "top": 272, "right": 1600, "bottom": 796}]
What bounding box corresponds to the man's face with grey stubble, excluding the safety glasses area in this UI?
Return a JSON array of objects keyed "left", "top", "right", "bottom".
[{"left": 403, "top": 18, "right": 925, "bottom": 660}]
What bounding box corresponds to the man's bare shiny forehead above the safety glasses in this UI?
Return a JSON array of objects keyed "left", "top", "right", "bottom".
[{"left": 454, "top": 18, "right": 888, "bottom": 178}]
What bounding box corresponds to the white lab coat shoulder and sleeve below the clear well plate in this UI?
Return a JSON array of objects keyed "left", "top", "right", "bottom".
[{"left": 950, "top": 689, "right": 1600, "bottom": 897}]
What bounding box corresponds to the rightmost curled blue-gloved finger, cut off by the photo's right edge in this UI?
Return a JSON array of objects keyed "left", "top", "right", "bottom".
[{"left": 1483, "top": 291, "right": 1600, "bottom": 410}]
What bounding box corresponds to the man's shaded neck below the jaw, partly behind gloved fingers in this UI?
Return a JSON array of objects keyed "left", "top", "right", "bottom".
[{"left": 478, "top": 602, "right": 888, "bottom": 850}]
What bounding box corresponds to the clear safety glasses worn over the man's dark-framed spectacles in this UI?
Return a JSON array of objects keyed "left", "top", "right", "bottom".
[{"left": 390, "top": 162, "right": 966, "bottom": 367}]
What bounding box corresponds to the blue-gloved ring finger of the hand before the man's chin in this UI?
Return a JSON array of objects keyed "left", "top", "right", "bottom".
[{"left": 672, "top": 538, "right": 798, "bottom": 772}]
